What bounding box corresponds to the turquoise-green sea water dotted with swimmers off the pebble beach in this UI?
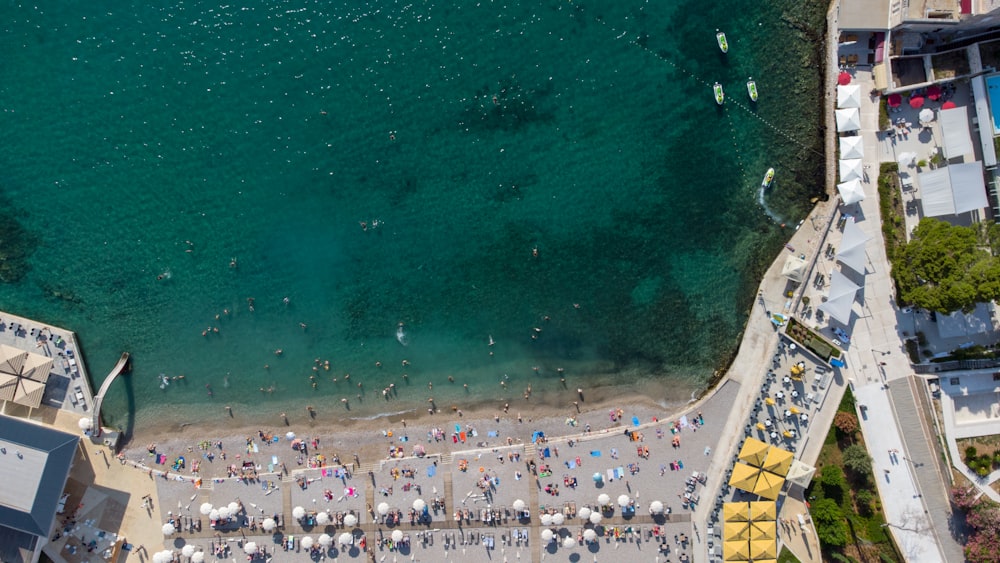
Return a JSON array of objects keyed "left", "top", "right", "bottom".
[{"left": 0, "top": 0, "right": 823, "bottom": 434}]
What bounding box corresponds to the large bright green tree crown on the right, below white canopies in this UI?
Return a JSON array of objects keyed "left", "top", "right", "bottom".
[{"left": 893, "top": 218, "right": 1000, "bottom": 313}]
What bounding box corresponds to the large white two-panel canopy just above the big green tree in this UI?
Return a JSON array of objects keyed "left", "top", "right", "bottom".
[{"left": 919, "top": 160, "right": 989, "bottom": 217}]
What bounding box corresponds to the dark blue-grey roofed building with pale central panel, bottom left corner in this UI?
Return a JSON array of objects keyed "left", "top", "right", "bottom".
[{"left": 0, "top": 415, "right": 79, "bottom": 563}]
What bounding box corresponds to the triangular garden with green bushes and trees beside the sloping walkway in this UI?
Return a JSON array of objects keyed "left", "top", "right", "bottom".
[{"left": 806, "top": 389, "right": 903, "bottom": 562}]
